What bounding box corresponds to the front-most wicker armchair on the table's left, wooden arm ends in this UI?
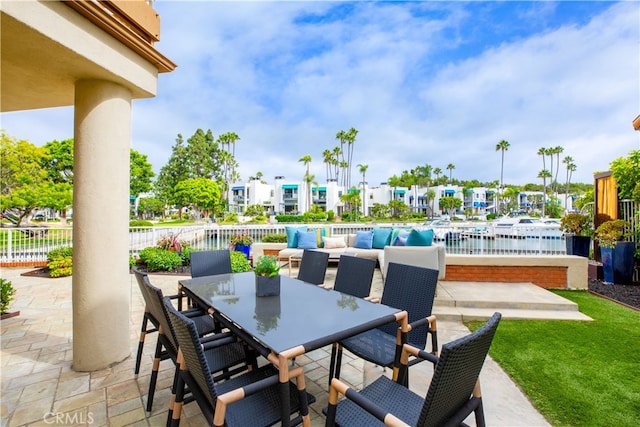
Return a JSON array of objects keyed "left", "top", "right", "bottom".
[{"left": 165, "top": 300, "right": 315, "bottom": 427}]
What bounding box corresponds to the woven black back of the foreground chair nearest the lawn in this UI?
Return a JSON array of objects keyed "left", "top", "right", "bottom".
[{"left": 418, "top": 312, "right": 501, "bottom": 426}]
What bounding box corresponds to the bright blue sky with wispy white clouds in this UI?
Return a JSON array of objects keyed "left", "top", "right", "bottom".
[{"left": 0, "top": 0, "right": 640, "bottom": 185}]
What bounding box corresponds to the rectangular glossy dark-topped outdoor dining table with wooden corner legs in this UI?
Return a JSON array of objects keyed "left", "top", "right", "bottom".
[{"left": 178, "top": 272, "right": 408, "bottom": 426}]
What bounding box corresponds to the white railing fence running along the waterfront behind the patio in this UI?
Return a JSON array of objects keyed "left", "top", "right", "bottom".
[{"left": 0, "top": 223, "right": 566, "bottom": 264}]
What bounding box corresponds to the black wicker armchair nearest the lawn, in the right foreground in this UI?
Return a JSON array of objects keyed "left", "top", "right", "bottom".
[{"left": 324, "top": 313, "right": 501, "bottom": 427}]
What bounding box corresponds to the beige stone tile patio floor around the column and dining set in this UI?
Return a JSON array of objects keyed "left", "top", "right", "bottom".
[{"left": 0, "top": 268, "right": 548, "bottom": 427}]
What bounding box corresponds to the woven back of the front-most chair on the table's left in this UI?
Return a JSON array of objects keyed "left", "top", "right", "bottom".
[{"left": 163, "top": 297, "right": 217, "bottom": 412}]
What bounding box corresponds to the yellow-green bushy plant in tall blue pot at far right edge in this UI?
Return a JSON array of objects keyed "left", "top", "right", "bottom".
[{"left": 594, "top": 219, "right": 635, "bottom": 283}]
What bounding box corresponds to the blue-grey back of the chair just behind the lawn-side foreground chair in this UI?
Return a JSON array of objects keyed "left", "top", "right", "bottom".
[{"left": 379, "top": 262, "right": 438, "bottom": 349}]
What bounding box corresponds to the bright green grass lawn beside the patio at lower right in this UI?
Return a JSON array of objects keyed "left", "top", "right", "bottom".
[{"left": 469, "top": 291, "right": 640, "bottom": 426}]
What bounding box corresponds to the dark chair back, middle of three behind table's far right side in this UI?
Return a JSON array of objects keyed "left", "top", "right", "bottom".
[{"left": 333, "top": 255, "right": 376, "bottom": 298}]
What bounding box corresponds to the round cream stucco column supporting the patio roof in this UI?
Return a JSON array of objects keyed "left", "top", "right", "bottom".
[{"left": 72, "top": 80, "right": 131, "bottom": 371}]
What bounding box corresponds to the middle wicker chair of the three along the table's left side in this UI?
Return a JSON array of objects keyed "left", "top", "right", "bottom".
[{"left": 135, "top": 271, "right": 251, "bottom": 412}]
